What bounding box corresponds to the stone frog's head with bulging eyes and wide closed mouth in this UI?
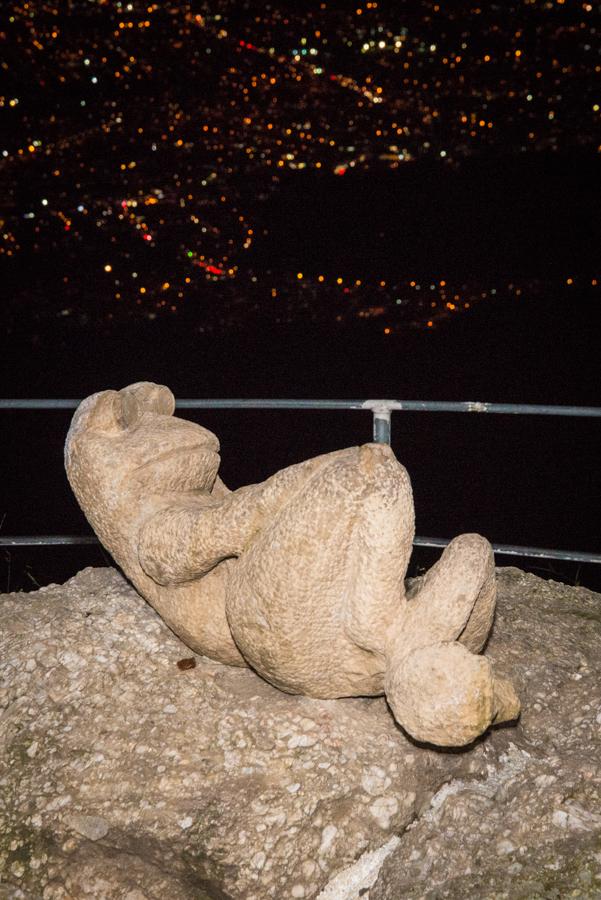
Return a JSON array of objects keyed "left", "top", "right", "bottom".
[{"left": 65, "top": 382, "right": 219, "bottom": 506}]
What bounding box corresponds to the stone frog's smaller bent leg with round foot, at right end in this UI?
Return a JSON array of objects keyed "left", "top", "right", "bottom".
[{"left": 385, "top": 534, "right": 520, "bottom": 746}]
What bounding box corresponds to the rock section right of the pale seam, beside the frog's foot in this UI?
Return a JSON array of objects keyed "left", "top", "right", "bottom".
[{"left": 369, "top": 569, "right": 601, "bottom": 900}]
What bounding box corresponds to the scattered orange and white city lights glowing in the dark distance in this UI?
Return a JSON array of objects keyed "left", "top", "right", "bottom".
[{"left": 0, "top": 0, "right": 601, "bottom": 335}]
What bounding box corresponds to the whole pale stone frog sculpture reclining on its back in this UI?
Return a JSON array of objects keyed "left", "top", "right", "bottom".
[{"left": 65, "top": 382, "right": 520, "bottom": 746}]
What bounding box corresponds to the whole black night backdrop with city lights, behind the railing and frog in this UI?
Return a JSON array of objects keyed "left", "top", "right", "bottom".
[{"left": 0, "top": 0, "right": 601, "bottom": 583}]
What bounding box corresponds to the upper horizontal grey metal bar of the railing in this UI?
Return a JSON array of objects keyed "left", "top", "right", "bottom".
[{"left": 0, "top": 398, "right": 601, "bottom": 418}]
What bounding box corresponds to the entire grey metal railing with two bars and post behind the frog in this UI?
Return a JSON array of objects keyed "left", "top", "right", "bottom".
[{"left": 0, "top": 399, "right": 601, "bottom": 564}]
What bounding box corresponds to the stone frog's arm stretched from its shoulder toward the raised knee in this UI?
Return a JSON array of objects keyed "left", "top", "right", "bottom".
[{"left": 138, "top": 450, "right": 358, "bottom": 584}]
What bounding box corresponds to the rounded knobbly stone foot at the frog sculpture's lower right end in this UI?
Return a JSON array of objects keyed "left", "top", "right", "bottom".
[{"left": 385, "top": 641, "right": 520, "bottom": 747}]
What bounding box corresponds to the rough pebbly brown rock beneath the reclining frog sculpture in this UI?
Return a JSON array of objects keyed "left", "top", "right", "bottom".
[{"left": 0, "top": 569, "right": 601, "bottom": 900}]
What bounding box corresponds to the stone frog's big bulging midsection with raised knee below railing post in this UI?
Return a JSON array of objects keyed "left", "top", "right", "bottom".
[{"left": 226, "top": 445, "right": 413, "bottom": 697}]
